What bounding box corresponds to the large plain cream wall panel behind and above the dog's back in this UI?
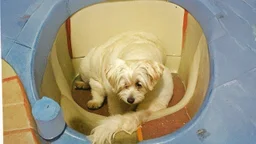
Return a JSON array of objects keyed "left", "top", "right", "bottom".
[{"left": 70, "top": 1, "right": 184, "bottom": 57}]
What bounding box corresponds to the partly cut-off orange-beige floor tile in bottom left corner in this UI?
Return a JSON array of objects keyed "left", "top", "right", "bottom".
[{"left": 4, "top": 130, "right": 38, "bottom": 144}]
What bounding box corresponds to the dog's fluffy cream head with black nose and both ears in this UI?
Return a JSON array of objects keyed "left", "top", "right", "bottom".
[{"left": 105, "top": 59, "right": 164, "bottom": 104}]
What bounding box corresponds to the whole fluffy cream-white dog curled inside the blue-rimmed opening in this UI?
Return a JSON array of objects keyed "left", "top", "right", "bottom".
[{"left": 79, "top": 32, "right": 173, "bottom": 144}]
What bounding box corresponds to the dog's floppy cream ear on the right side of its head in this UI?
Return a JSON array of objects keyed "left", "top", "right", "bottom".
[{"left": 142, "top": 60, "right": 164, "bottom": 90}]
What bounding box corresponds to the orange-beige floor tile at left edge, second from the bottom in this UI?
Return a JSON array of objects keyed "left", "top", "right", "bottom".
[{"left": 3, "top": 104, "right": 31, "bottom": 131}]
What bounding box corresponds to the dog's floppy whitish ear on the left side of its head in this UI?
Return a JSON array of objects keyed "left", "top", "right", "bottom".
[{"left": 105, "top": 59, "right": 125, "bottom": 91}]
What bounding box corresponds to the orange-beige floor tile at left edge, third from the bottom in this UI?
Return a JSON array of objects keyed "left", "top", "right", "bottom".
[{"left": 3, "top": 78, "right": 24, "bottom": 106}]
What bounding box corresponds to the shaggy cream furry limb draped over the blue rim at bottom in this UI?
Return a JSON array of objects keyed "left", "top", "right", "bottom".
[{"left": 89, "top": 110, "right": 151, "bottom": 144}]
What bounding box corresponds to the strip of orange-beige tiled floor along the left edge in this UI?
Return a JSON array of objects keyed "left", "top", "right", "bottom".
[{"left": 2, "top": 60, "right": 39, "bottom": 144}]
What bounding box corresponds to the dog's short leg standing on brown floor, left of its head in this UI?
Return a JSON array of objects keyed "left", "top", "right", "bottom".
[{"left": 87, "top": 79, "right": 106, "bottom": 109}]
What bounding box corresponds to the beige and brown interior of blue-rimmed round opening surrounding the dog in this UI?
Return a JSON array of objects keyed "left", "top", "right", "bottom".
[{"left": 40, "top": 1, "right": 210, "bottom": 143}]
